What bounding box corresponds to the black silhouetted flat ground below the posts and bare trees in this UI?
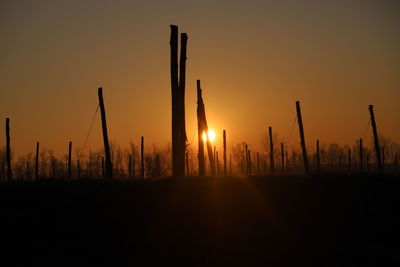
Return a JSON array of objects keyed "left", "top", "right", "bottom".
[{"left": 0, "top": 176, "right": 400, "bottom": 266}]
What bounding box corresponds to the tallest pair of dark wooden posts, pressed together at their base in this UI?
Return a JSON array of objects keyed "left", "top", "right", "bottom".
[{"left": 170, "top": 25, "right": 187, "bottom": 176}]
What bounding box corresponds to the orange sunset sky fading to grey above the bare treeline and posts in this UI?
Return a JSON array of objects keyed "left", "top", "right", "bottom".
[{"left": 0, "top": 0, "right": 400, "bottom": 158}]
